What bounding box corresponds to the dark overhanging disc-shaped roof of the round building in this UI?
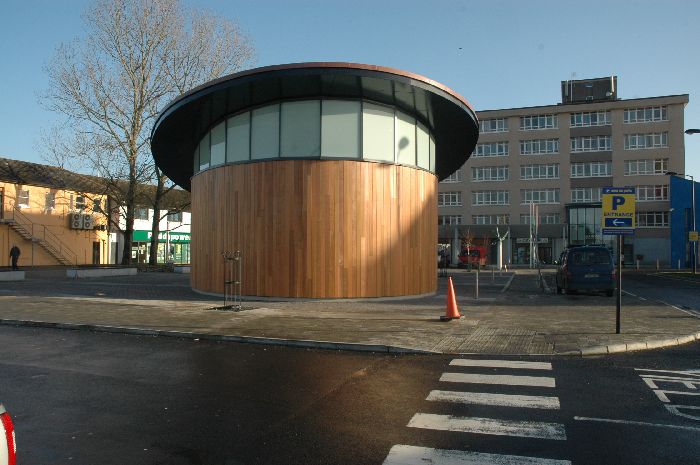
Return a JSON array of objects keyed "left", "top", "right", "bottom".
[{"left": 151, "top": 63, "right": 479, "bottom": 190}]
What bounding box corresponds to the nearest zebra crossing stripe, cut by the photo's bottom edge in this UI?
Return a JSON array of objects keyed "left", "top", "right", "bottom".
[{"left": 383, "top": 445, "right": 571, "bottom": 465}]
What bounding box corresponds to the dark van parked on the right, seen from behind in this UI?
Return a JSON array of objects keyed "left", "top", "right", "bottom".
[{"left": 556, "top": 245, "right": 615, "bottom": 297}]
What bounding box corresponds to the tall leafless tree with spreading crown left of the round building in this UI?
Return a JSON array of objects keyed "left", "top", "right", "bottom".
[{"left": 43, "top": 0, "right": 254, "bottom": 264}]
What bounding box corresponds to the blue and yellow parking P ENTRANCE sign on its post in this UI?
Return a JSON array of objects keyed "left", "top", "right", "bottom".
[{"left": 601, "top": 187, "right": 636, "bottom": 334}]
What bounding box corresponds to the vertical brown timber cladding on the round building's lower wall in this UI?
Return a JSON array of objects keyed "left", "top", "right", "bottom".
[{"left": 191, "top": 160, "right": 437, "bottom": 298}]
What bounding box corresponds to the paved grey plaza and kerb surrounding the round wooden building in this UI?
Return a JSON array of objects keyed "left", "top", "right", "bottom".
[{"left": 0, "top": 269, "right": 700, "bottom": 355}]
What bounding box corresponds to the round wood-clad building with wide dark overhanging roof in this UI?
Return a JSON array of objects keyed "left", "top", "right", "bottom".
[{"left": 151, "top": 63, "right": 478, "bottom": 298}]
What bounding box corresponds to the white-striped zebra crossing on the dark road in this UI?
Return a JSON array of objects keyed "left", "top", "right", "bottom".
[{"left": 384, "top": 358, "right": 571, "bottom": 465}]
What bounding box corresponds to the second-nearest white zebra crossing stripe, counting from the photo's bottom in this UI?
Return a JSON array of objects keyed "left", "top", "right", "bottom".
[{"left": 407, "top": 413, "right": 566, "bottom": 441}]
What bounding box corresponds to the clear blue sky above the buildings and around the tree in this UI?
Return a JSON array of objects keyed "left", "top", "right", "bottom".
[{"left": 0, "top": 0, "right": 700, "bottom": 178}]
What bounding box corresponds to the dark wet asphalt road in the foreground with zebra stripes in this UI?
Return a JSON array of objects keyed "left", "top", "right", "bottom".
[{"left": 0, "top": 327, "right": 700, "bottom": 465}]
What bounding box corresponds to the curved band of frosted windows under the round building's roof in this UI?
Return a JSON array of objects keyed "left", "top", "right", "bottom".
[{"left": 194, "top": 99, "right": 435, "bottom": 173}]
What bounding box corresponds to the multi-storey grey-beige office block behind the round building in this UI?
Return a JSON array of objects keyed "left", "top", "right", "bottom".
[{"left": 438, "top": 77, "right": 688, "bottom": 265}]
